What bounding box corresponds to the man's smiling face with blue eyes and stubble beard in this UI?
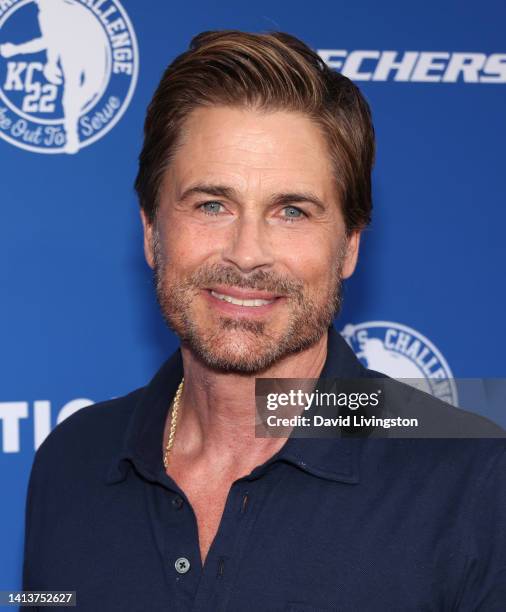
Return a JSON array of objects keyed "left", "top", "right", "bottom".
[{"left": 142, "top": 107, "right": 359, "bottom": 374}]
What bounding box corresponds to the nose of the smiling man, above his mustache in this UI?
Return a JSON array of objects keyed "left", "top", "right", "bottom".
[{"left": 222, "top": 216, "right": 274, "bottom": 272}]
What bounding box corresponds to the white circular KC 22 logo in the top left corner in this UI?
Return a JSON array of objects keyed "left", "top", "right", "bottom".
[{"left": 0, "top": 0, "right": 139, "bottom": 153}]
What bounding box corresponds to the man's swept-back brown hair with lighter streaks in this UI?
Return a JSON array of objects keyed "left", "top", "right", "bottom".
[{"left": 135, "top": 30, "right": 375, "bottom": 234}]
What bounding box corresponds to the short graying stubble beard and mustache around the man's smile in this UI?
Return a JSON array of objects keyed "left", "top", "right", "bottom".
[{"left": 153, "top": 232, "right": 346, "bottom": 374}]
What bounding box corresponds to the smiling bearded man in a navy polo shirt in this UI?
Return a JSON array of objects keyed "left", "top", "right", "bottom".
[{"left": 24, "top": 31, "right": 506, "bottom": 612}]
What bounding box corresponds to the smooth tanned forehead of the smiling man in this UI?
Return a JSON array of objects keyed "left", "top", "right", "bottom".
[{"left": 168, "top": 106, "right": 334, "bottom": 198}]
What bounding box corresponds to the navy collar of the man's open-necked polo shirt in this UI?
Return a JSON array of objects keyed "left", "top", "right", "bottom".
[{"left": 106, "top": 325, "right": 367, "bottom": 484}]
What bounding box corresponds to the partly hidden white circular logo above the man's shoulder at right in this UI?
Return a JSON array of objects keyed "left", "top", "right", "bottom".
[{"left": 341, "top": 321, "right": 458, "bottom": 406}]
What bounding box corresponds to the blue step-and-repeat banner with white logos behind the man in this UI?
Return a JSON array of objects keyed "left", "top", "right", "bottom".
[{"left": 0, "top": 0, "right": 506, "bottom": 589}]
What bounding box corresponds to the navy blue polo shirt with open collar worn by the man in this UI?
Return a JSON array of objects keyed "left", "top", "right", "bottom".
[{"left": 23, "top": 327, "right": 506, "bottom": 612}]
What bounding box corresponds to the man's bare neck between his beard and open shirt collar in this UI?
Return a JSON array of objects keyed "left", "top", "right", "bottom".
[{"left": 174, "top": 333, "right": 328, "bottom": 472}]
